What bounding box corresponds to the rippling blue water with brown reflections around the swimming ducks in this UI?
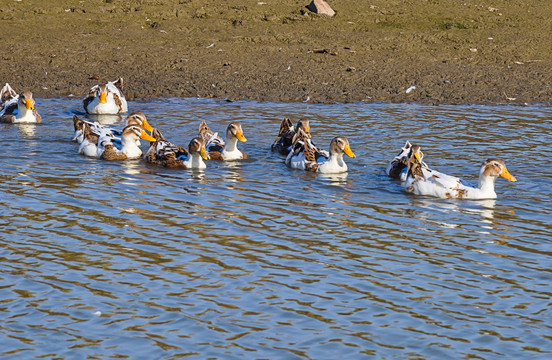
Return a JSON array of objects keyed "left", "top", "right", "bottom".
[{"left": 0, "top": 99, "right": 552, "bottom": 359}]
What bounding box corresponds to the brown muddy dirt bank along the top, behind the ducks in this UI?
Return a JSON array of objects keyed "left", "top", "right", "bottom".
[{"left": 0, "top": 0, "right": 552, "bottom": 105}]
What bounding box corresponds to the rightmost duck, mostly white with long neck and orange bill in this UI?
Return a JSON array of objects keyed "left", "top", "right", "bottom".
[{"left": 404, "top": 152, "right": 517, "bottom": 200}]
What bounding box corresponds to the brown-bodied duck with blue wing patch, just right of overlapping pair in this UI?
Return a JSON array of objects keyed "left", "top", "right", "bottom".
[{"left": 144, "top": 129, "right": 209, "bottom": 169}]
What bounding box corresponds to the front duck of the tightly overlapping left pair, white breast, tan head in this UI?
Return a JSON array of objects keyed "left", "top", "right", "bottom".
[{"left": 98, "top": 125, "right": 155, "bottom": 160}]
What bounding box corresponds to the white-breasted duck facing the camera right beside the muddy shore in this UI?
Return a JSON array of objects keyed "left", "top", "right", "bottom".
[{"left": 82, "top": 77, "right": 128, "bottom": 115}]
